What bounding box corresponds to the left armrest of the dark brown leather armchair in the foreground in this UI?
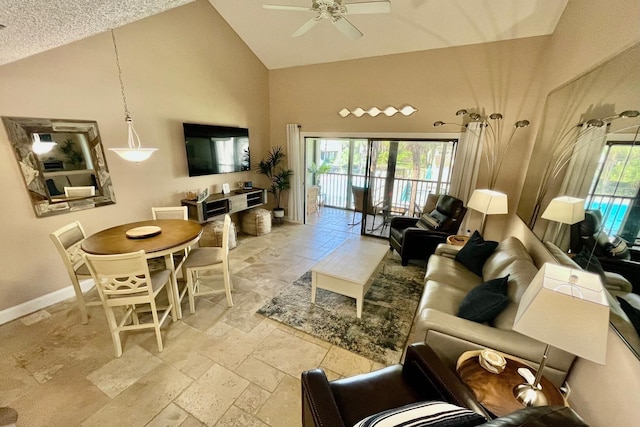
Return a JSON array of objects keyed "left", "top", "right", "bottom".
[{"left": 300, "top": 369, "right": 344, "bottom": 427}]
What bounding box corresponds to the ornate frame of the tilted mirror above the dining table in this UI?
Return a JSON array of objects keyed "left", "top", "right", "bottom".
[{"left": 2, "top": 117, "right": 116, "bottom": 217}]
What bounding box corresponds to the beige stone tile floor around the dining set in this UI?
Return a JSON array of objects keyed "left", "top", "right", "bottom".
[{"left": 0, "top": 209, "right": 408, "bottom": 427}]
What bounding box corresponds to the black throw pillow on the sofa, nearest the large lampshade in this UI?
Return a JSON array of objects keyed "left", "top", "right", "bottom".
[{"left": 458, "top": 275, "right": 509, "bottom": 323}]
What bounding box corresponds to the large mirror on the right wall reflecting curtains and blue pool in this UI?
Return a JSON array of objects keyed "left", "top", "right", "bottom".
[{"left": 516, "top": 44, "right": 640, "bottom": 358}]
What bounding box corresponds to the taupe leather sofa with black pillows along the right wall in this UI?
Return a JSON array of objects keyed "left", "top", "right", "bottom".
[{"left": 407, "top": 237, "right": 575, "bottom": 386}]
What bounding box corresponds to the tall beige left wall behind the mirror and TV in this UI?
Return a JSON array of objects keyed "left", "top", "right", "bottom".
[{"left": 0, "top": 0, "right": 269, "bottom": 313}]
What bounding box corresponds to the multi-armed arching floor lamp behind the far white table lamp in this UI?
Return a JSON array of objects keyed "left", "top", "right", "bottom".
[{"left": 433, "top": 108, "right": 530, "bottom": 189}]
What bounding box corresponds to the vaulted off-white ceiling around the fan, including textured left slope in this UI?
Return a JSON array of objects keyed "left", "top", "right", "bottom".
[{"left": 0, "top": 0, "right": 568, "bottom": 69}]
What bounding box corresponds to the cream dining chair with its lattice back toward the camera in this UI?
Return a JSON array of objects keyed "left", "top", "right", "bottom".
[{"left": 84, "top": 250, "right": 174, "bottom": 357}]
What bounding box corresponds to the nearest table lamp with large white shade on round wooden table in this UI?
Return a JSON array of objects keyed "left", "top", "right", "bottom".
[{"left": 513, "top": 263, "right": 609, "bottom": 406}]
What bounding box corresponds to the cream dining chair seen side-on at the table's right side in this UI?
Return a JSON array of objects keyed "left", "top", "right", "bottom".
[{"left": 182, "top": 215, "right": 233, "bottom": 313}]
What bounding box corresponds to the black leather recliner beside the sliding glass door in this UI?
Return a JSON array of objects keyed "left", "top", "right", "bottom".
[{"left": 389, "top": 195, "right": 467, "bottom": 265}]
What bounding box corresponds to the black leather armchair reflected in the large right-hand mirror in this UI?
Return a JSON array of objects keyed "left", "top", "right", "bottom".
[{"left": 570, "top": 210, "right": 640, "bottom": 293}]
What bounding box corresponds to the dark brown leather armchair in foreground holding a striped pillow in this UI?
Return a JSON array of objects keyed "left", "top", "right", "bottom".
[{"left": 301, "top": 343, "right": 586, "bottom": 427}]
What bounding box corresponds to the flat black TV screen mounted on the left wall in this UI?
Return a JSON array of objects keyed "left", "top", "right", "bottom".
[{"left": 182, "top": 123, "right": 251, "bottom": 176}]
